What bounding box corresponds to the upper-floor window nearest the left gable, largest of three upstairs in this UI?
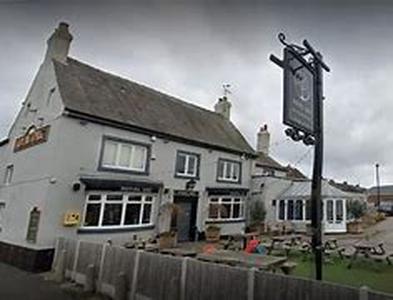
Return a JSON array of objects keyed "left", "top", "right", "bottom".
[{"left": 101, "top": 138, "right": 148, "bottom": 173}]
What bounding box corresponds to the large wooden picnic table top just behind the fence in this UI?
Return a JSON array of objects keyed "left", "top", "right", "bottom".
[{"left": 197, "top": 250, "right": 287, "bottom": 272}]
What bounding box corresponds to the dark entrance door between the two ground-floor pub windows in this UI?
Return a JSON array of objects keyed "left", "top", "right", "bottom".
[{"left": 173, "top": 196, "right": 198, "bottom": 242}]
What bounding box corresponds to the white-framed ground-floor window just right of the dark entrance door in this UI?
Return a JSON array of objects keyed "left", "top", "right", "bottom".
[{"left": 208, "top": 196, "right": 244, "bottom": 221}]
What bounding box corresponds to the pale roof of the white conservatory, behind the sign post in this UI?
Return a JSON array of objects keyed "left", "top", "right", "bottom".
[{"left": 278, "top": 180, "right": 349, "bottom": 199}]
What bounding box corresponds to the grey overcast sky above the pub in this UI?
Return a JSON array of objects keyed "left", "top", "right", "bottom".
[{"left": 0, "top": 0, "right": 393, "bottom": 186}]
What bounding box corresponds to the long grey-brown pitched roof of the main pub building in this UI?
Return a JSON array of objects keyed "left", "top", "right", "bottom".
[{"left": 53, "top": 58, "right": 255, "bottom": 155}]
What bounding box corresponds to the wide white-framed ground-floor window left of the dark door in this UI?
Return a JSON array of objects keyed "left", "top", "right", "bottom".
[{"left": 83, "top": 192, "right": 156, "bottom": 228}]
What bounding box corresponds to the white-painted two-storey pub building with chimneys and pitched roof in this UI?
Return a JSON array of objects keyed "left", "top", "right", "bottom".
[{"left": 0, "top": 23, "right": 255, "bottom": 271}]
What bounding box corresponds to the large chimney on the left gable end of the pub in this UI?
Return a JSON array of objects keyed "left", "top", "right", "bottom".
[{"left": 45, "top": 22, "right": 72, "bottom": 63}]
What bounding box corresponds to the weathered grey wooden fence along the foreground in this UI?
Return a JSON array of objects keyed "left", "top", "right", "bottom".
[{"left": 53, "top": 238, "right": 393, "bottom": 300}]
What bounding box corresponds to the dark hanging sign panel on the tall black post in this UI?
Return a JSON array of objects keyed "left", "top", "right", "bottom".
[{"left": 284, "top": 47, "right": 315, "bottom": 135}]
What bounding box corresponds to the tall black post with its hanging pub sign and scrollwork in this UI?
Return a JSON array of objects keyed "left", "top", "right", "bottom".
[{"left": 270, "top": 33, "right": 330, "bottom": 280}]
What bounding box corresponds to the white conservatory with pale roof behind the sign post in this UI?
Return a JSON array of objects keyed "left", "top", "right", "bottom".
[{"left": 274, "top": 180, "right": 349, "bottom": 233}]
